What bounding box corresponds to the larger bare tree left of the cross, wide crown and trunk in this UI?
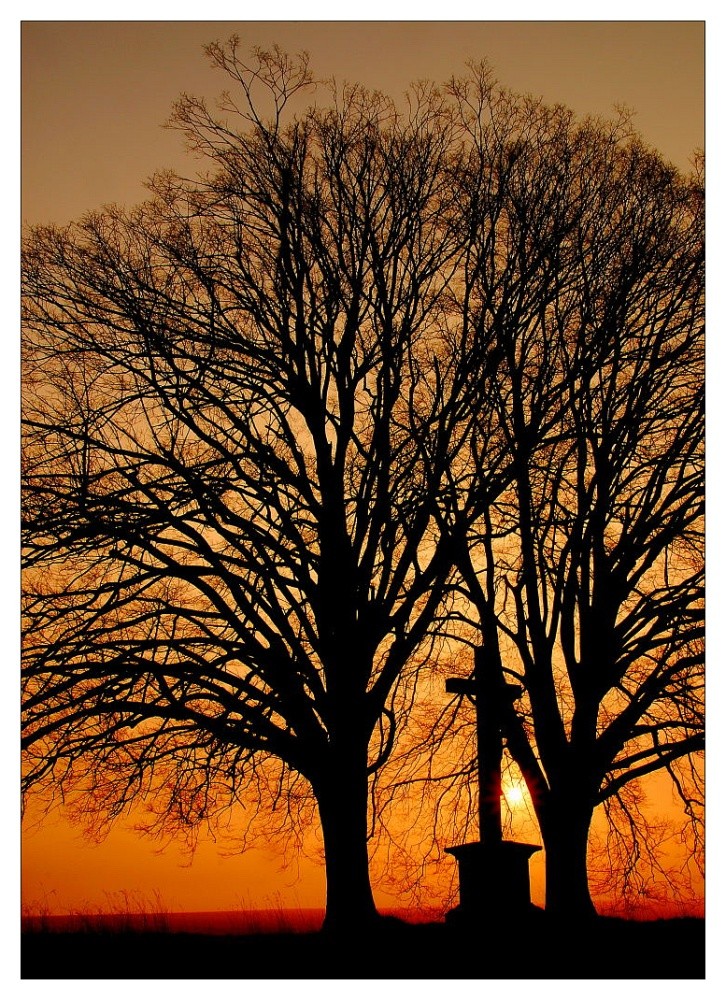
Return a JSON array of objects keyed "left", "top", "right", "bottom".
[{"left": 23, "top": 39, "right": 478, "bottom": 926}]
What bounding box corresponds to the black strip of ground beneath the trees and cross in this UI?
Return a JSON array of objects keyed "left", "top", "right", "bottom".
[{"left": 21, "top": 911, "right": 705, "bottom": 980}]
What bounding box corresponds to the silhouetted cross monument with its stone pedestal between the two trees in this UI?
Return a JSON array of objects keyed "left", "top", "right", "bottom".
[{"left": 446, "top": 648, "right": 541, "bottom": 923}]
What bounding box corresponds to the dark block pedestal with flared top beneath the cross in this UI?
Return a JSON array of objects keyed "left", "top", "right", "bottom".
[{"left": 446, "top": 840, "right": 542, "bottom": 923}]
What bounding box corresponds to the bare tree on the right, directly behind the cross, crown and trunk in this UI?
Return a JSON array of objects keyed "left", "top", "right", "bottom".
[{"left": 404, "top": 77, "right": 704, "bottom": 915}]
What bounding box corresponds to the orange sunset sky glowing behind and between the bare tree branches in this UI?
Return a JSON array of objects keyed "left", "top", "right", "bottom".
[{"left": 22, "top": 21, "right": 704, "bottom": 940}]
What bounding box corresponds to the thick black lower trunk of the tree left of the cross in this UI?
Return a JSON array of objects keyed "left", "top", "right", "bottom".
[{"left": 314, "top": 754, "right": 378, "bottom": 931}]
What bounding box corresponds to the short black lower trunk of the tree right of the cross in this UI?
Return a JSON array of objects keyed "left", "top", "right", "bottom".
[{"left": 541, "top": 793, "right": 595, "bottom": 920}]
